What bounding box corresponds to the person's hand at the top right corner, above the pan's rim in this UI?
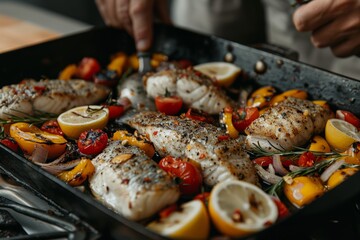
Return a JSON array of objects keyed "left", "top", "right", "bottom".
[{"left": 293, "top": 0, "right": 360, "bottom": 57}]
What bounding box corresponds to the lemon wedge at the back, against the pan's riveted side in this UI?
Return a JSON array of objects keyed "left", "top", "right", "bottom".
[{"left": 194, "top": 62, "right": 241, "bottom": 87}]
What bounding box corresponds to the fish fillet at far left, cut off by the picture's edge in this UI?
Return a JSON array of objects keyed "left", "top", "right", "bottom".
[{"left": 0, "top": 79, "right": 110, "bottom": 119}]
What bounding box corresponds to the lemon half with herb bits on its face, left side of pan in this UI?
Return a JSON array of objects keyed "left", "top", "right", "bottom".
[{"left": 57, "top": 105, "right": 109, "bottom": 139}]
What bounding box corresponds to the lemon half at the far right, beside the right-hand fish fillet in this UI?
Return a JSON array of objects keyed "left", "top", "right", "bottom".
[{"left": 325, "top": 118, "right": 360, "bottom": 152}]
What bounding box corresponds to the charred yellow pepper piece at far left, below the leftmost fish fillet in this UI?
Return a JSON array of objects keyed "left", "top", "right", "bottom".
[{"left": 10, "top": 122, "right": 67, "bottom": 159}]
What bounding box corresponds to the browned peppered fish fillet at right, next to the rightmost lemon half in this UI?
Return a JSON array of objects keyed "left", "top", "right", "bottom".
[{"left": 245, "top": 98, "right": 331, "bottom": 151}]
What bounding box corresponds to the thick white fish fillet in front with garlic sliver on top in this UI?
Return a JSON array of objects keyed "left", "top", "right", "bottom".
[{"left": 89, "top": 141, "right": 180, "bottom": 221}]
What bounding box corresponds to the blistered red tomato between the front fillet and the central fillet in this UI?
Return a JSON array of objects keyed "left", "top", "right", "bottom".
[{"left": 159, "top": 156, "right": 202, "bottom": 196}]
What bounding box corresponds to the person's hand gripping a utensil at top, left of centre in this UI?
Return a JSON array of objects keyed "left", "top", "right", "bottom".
[{"left": 96, "top": 0, "right": 170, "bottom": 51}]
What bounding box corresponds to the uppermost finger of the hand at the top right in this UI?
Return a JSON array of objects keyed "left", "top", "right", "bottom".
[{"left": 293, "top": 0, "right": 357, "bottom": 32}]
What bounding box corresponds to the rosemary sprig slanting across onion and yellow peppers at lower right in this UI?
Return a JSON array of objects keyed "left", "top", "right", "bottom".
[{"left": 266, "top": 156, "right": 340, "bottom": 196}]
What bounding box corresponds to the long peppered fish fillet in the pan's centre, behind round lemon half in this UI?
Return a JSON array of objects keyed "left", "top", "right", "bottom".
[{"left": 128, "top": 112, "right": 258, "bottom": 186}]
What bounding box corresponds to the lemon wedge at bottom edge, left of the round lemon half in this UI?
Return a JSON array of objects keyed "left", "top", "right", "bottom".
[{"left": 147, "top": 200, "right": 210, "bottom": 239}]
